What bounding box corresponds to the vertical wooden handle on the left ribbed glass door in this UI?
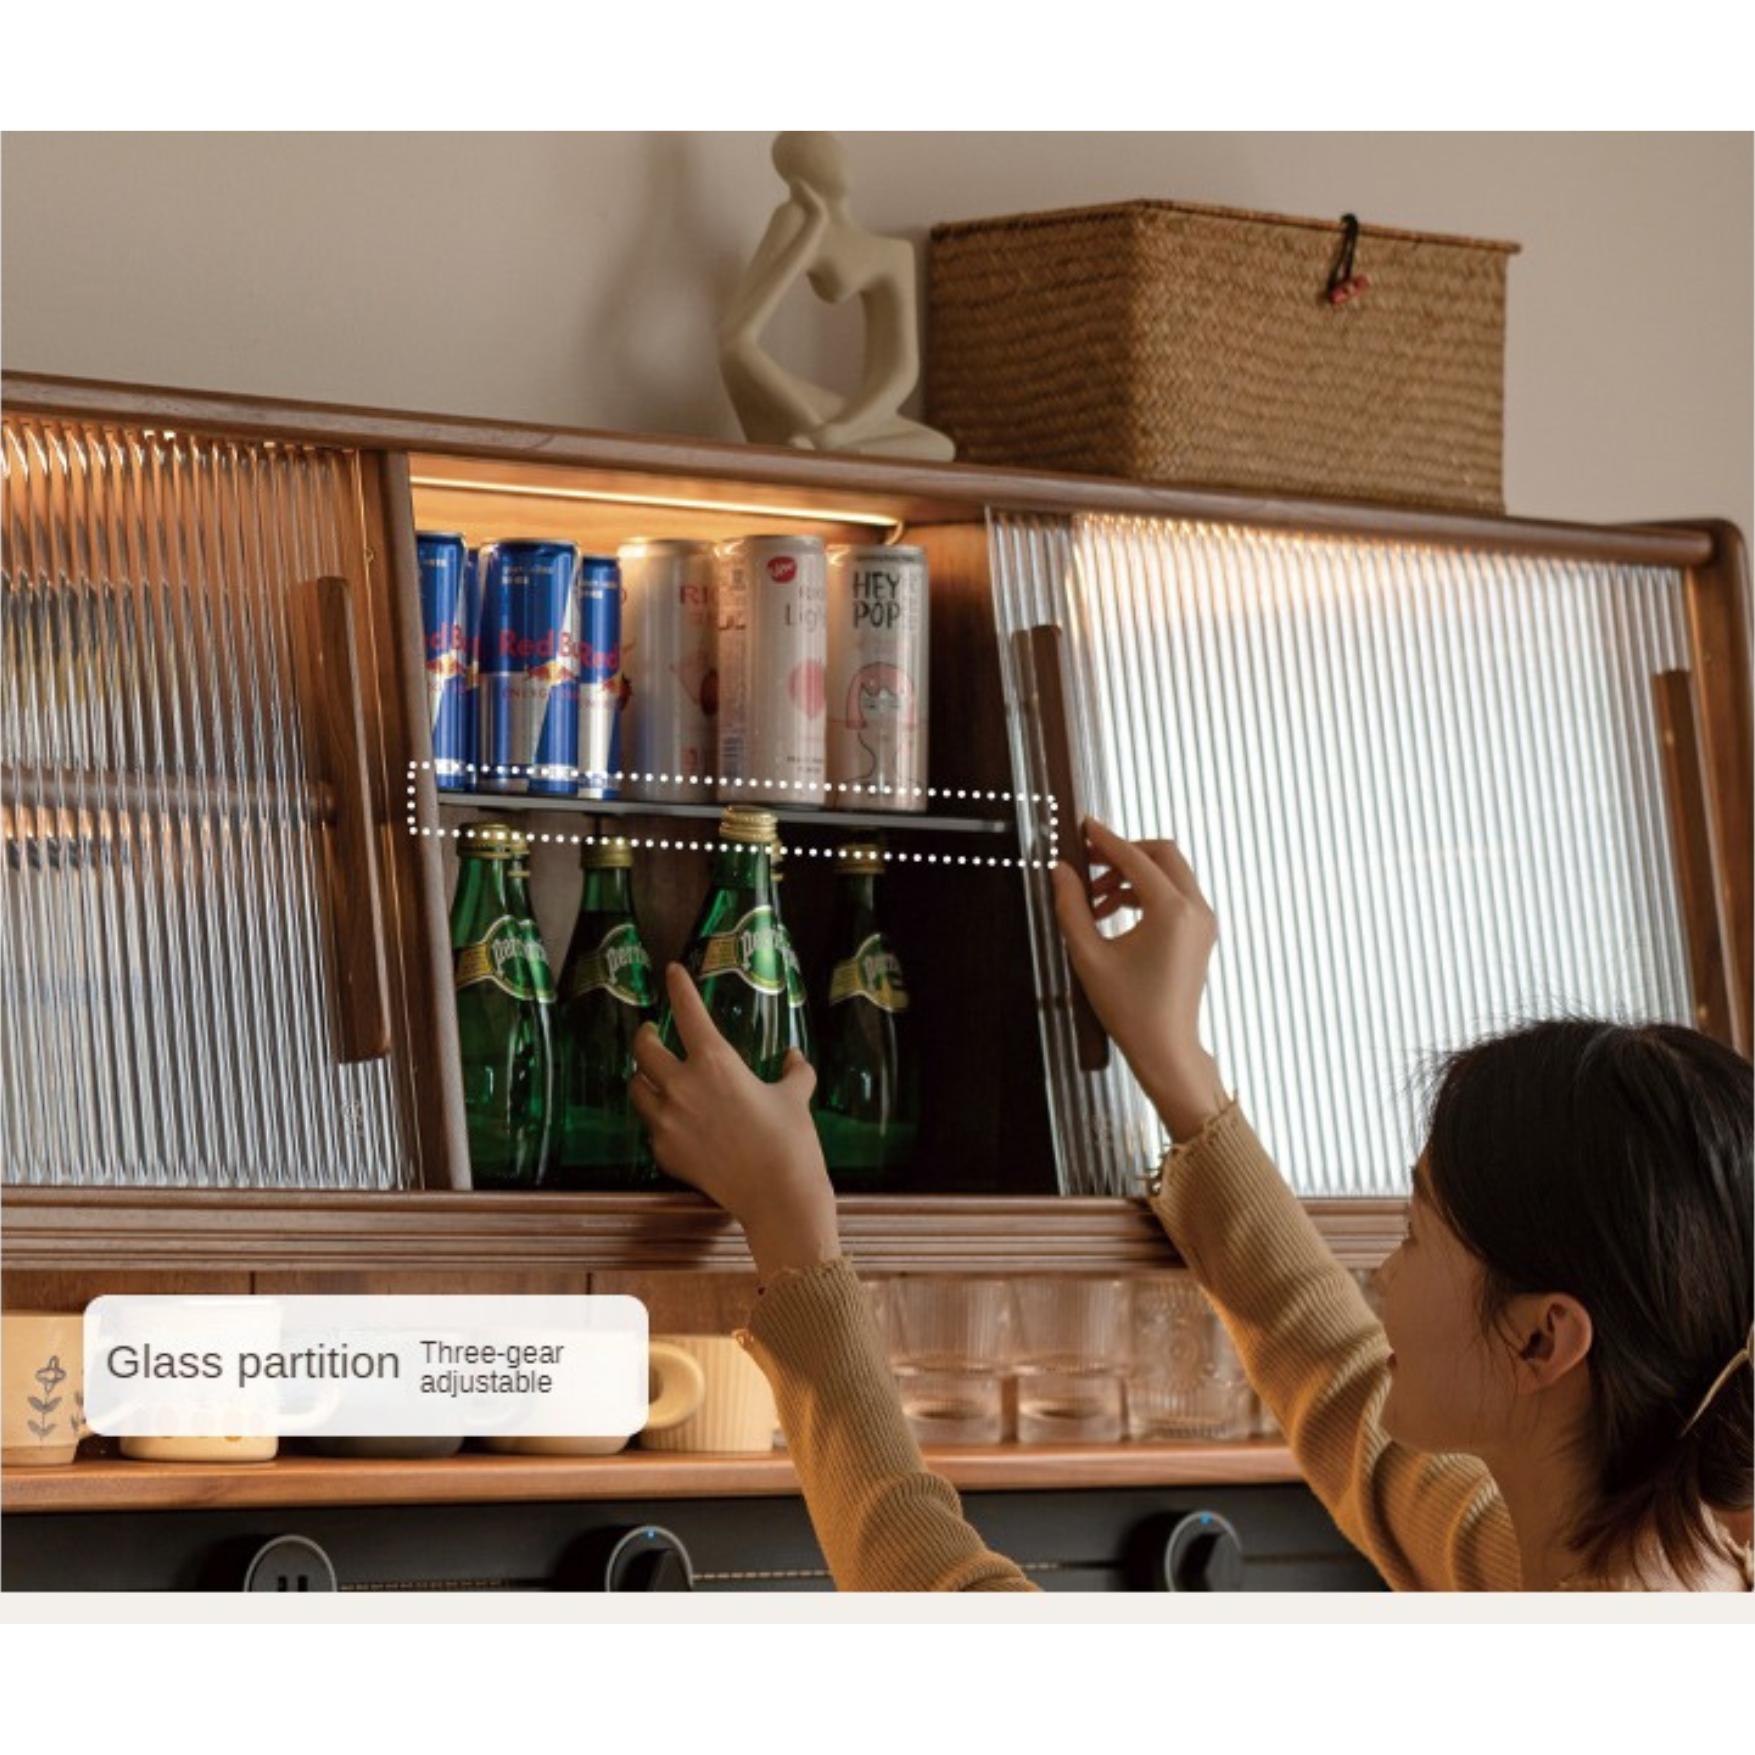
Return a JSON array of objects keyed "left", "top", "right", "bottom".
[{"left": 291, "top": 577, "right": 390, "bottom": 1062}]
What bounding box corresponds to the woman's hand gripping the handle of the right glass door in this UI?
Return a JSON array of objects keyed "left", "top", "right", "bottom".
[{"left": 1053, "top": 818, "right": 1227, "bottom": 1139}]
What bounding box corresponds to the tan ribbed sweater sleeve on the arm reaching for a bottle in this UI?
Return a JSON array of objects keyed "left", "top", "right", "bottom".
[{"left": 739, "top": 1257, "right": 1034, "bottom": 1590}]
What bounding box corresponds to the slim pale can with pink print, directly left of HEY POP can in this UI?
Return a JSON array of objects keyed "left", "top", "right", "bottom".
[{"left": 714, "top": 537, "right": 828, "bottom": 811}]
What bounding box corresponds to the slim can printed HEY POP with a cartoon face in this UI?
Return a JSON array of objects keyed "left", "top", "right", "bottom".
[{"left": 828, "top": 544, "right": 930, "bottom": 811}]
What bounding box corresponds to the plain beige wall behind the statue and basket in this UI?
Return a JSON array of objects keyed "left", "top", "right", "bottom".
[{"left": 0, "top": 133, "right": 1755, "bottom": 528}]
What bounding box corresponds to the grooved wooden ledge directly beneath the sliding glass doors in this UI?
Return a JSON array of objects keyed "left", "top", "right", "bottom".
[{"left": 0, "top": 1188, "right": 1406, "bottom": 1276}]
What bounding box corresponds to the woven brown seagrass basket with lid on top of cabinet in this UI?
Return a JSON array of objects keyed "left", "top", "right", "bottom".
[{"left": 927, "top": 202, "right": 1518, "bottom": 511}]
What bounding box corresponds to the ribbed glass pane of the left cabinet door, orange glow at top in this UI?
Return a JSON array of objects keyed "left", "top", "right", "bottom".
[{"left": 0, "top": 418, "right": 412, "bottom": 1188}]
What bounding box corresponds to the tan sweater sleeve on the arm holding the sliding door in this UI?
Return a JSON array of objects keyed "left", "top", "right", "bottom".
[{"left": 1151, "top": 1104, "right": 1522, "bottom": 1590}]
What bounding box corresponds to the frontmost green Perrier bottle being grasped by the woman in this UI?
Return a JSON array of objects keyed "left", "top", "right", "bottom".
[{"left": 658, "top": 806, "right": 807, "bottom": 1085}]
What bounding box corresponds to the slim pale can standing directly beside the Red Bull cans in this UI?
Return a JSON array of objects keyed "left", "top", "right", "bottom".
[{"left": 616, "top": 537, "right": 720, "bottom": 804}]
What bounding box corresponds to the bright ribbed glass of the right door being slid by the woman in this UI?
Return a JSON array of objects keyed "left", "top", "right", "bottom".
[{"left": 990, "top": 514, "right": 1692, "bottom": 1197}]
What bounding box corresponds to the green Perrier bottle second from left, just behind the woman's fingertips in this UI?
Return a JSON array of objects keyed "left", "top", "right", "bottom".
[{"left": 553, "top": 841, "right": 658, "bottom": 1188}]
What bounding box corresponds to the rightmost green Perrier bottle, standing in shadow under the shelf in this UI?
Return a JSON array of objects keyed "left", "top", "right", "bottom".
[{"left": 816, "top": 842, "right": 920, "bottom": 1192}]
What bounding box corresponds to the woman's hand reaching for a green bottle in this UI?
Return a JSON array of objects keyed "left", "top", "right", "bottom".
[{"left": 628, "top": 963, "right": 841, "bottom": 1279}]
